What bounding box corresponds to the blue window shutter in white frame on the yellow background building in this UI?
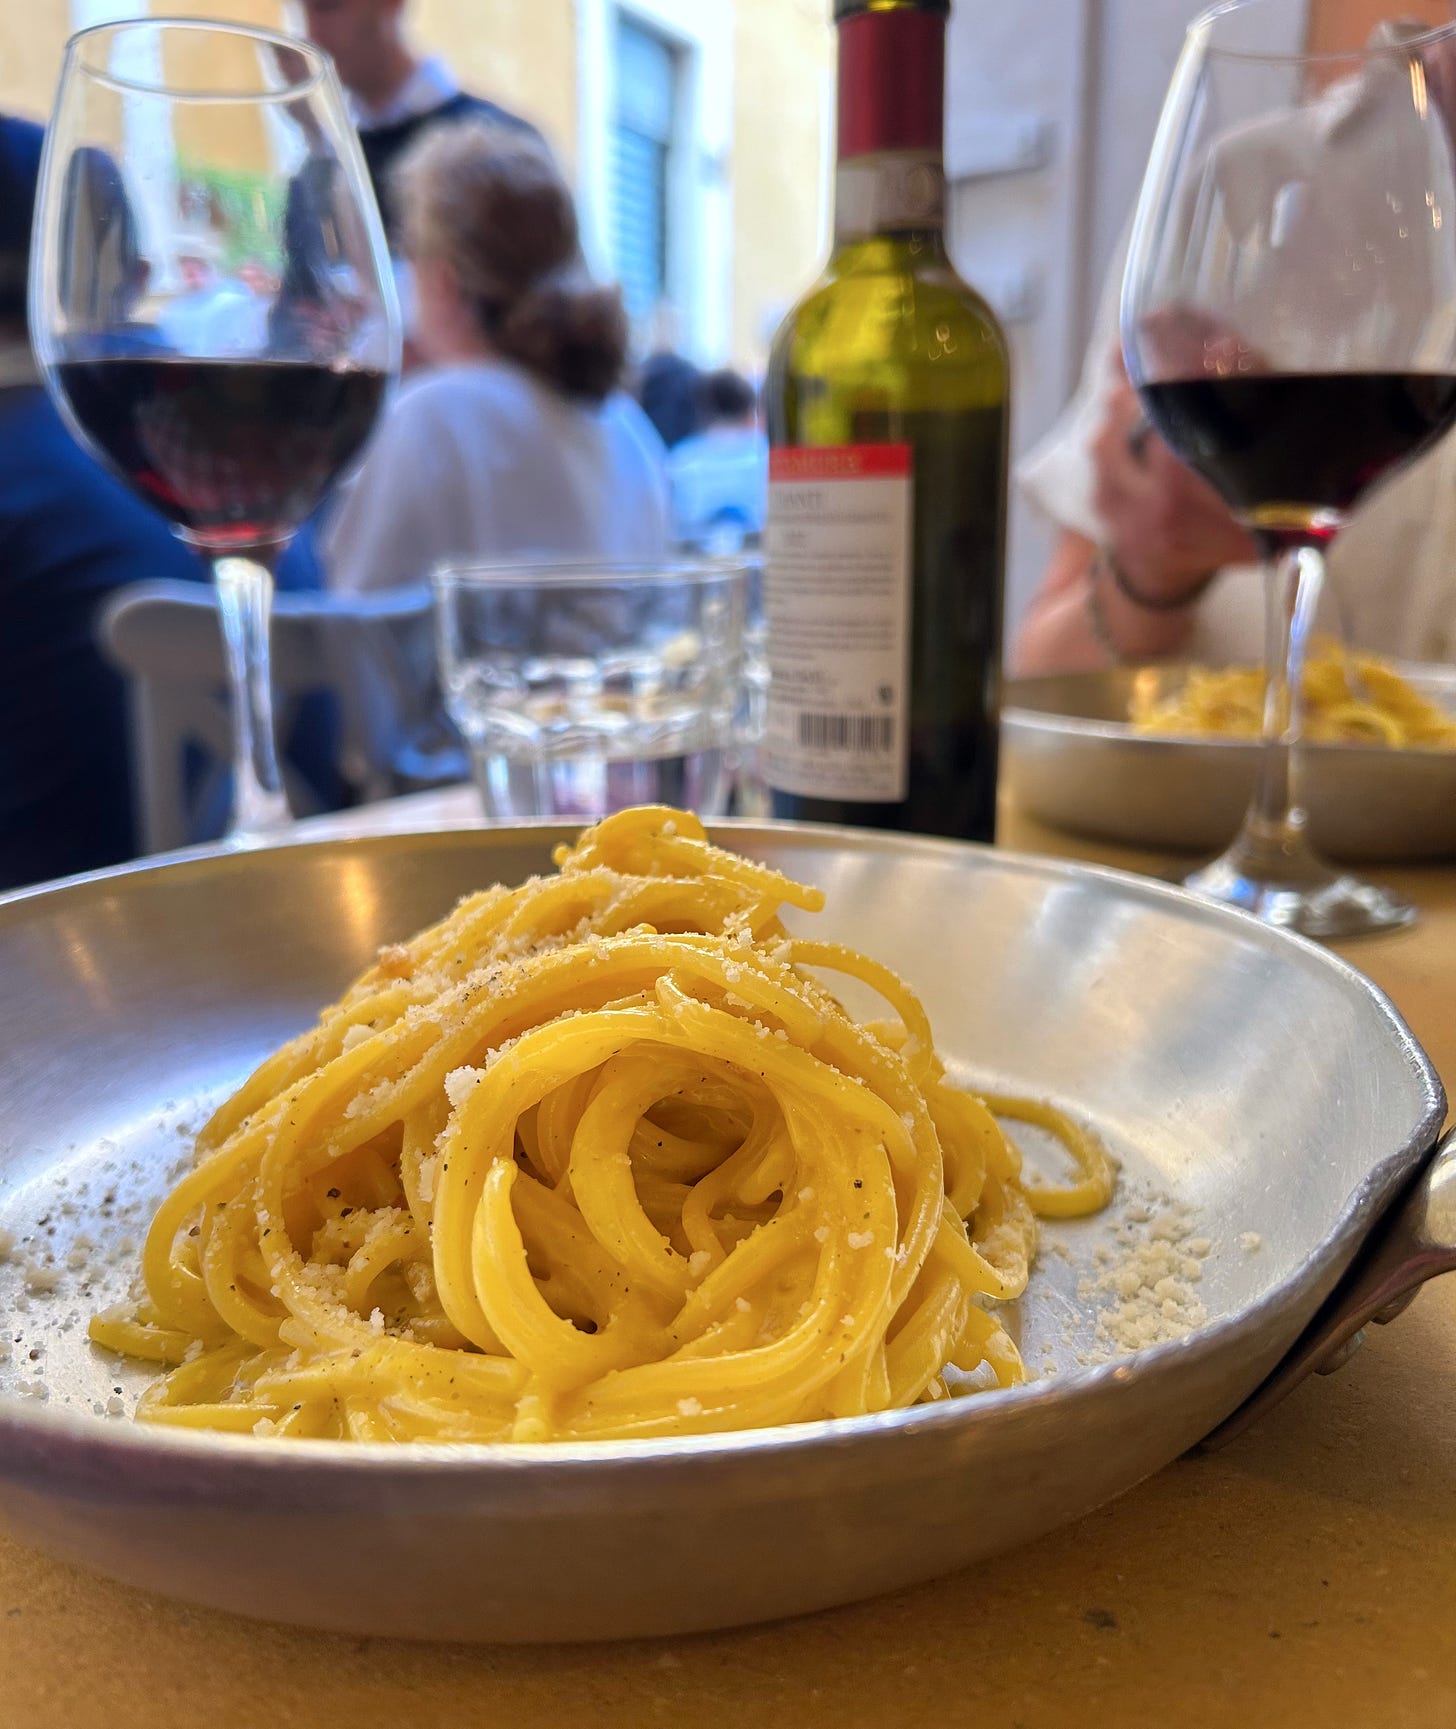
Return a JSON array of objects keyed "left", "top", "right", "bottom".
[{"left": 609, "top": 12, "right": 678, "bottom": 323}]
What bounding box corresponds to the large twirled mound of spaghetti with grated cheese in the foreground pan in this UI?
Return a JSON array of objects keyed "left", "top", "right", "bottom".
[{"left": 90, "top": 807, "right": 1112, "bottom": 1442}]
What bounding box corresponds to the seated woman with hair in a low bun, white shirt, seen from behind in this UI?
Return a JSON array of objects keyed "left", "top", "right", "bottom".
[{"left": 322, "top": 123, "right": 671, "bottom": 591}]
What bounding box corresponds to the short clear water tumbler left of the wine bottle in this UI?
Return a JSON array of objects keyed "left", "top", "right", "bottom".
[{"left": 434, "top": 560, "right": 749, "bottom": 823}]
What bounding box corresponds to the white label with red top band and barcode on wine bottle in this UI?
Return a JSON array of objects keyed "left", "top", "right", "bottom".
[{"left": 763, "top": 444, "right": 913, "bottom": 804}]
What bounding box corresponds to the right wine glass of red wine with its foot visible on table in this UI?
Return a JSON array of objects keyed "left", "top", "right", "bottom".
[{"left": 1122, "top": 0, "right": 1456, "bottom": 937}]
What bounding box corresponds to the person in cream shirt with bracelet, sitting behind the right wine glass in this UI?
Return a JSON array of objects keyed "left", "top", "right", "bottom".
[{"left": 1010, "top": 22, "right": 1456, "bottom": 673}]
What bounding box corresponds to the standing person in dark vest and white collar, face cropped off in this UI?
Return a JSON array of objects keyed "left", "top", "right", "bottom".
[{"left": 301, "top": 0, "right": 540, "bottom": 251}]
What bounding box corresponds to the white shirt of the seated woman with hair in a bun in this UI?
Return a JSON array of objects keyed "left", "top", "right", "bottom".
[{"left": 323, "top": 361, "right": 671, "bottom": 593}]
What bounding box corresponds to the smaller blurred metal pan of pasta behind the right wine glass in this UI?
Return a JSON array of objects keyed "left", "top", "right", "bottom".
[{"left": 1003, "top": 657, "right": 1456, "bottom": 863}]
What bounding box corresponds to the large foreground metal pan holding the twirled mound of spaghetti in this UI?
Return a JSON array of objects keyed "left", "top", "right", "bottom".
[{"left": 0, "top": 809, "right": 1456, "bottom": 1641}]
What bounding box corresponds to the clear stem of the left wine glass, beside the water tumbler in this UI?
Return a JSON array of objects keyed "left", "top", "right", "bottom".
[{"left": 213, "top": 557, "right": 289, "bottom": 840}]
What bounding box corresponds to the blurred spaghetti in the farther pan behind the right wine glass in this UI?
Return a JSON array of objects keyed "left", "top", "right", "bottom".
[{"left": 1131, "top": 645, "right": 1456, "bottom": 750}]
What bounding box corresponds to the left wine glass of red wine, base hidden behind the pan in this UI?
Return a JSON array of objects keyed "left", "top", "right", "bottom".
[{"left": 29, "top": 19, "right": 399, "bottom": 842}]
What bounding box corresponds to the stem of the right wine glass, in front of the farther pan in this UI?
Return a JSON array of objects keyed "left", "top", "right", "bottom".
[{"left": 1242, "top": 545, "right": 1330, "bottom": 884}]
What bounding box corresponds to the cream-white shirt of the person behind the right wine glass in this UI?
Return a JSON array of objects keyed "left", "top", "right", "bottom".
[{"left": 1017, "top": 35, "right": 1456, "bottom": 664}]
